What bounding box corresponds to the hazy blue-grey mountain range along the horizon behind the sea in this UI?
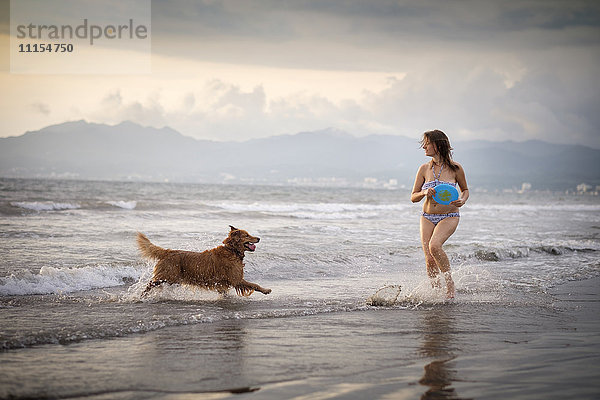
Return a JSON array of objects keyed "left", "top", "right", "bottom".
[{"left": 0, "top": 121, "right": 600, "bottom": 190}]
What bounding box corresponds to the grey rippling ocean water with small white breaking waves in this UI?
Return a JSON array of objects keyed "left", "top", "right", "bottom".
[{"left": 0, "top": 179, "right": 600, "bottom": 398}]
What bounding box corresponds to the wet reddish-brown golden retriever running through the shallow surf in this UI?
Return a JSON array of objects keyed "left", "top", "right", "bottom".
[{"left": 137, "top": 225, "right": 271, "bottom": 296}]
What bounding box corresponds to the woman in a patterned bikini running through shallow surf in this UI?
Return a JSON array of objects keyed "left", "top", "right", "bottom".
[{"left": 411, "top": 130, "right": 469, "bottom": 298}]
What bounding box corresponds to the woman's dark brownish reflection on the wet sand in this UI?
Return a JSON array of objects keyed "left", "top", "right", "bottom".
[{"left": 419, "top": 307, "right": 460, "bottom": 400}]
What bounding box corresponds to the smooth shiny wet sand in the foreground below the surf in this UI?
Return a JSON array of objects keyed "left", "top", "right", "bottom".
[{"left": 0, "top": 278, "right": 600, "bottom": 399}]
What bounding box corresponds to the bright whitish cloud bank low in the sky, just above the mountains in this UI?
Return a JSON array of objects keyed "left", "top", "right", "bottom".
[{"left": 72, "top": 48, "right": 600, "bottom": 147}]
